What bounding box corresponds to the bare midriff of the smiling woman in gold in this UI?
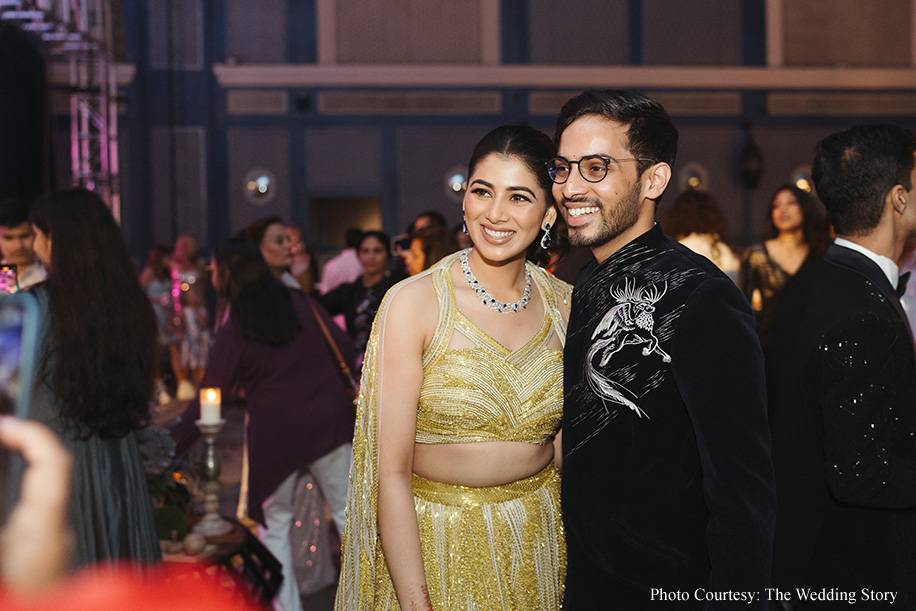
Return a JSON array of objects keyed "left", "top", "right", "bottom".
[{"left": 413, "top": 441, "right": 554, "bottom": 487}]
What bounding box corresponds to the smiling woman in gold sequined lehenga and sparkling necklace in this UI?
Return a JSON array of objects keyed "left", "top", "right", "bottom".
[{"left": 335, "top": 126, "right": 570, "bottom": 611}]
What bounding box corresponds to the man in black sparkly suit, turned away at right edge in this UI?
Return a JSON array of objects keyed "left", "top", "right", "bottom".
[{"left": 771, "top": 125, "right": 916, "bottom": 609}]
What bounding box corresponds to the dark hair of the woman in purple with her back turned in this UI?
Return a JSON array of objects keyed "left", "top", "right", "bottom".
[{"left": 214, "top": 237, "right": 299, "bottom": 346}]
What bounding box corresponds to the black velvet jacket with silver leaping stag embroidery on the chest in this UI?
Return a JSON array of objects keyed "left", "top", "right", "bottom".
[{"left": 562, "top": 224, "right": 775, "bottom": 611}]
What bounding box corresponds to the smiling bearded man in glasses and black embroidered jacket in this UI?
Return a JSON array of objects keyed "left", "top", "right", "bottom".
[{"left": 548, "top": 91, "right": 775, "bottom": 611}]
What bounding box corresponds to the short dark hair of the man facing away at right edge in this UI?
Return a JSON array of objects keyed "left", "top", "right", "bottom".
[{"left": 811, "top": 124, "right": 916, "bottom": 236}]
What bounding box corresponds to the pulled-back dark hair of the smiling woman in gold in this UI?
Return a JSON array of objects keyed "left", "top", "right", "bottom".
[{"left": 468, "top": 125, "right": 557, "bottom": 197}]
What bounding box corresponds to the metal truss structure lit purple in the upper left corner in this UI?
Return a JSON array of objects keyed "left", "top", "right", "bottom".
[{"left": 0, "top": 0, "right": 121, "bottom": 220}]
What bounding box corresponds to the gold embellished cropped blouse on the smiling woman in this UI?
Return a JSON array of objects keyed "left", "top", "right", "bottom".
[{"left": 416, "top": 256, "right": 568, "bottom": 445}]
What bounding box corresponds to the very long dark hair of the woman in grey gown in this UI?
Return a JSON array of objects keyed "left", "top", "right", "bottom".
[{"left": 31, "top": 189, "right": 157, "bottom": 437}]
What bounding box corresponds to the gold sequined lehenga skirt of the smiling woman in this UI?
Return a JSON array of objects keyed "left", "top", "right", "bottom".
[{"left": 375, "top": 463, "right": 566, "bottom": 611}]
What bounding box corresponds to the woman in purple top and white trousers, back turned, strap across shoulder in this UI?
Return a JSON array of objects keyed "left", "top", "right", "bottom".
[{"left": 179, "top": 238, "right": 353, "bottom": 611}]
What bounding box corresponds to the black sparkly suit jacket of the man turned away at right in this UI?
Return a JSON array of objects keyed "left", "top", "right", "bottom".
[{"left": 768, "top": 244, "right": 916, "bottom": 609}]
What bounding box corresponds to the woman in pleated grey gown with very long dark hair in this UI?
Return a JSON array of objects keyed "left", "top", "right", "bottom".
[{"left": 30, "top": 189, "right": 160, "bottom": 567}]
